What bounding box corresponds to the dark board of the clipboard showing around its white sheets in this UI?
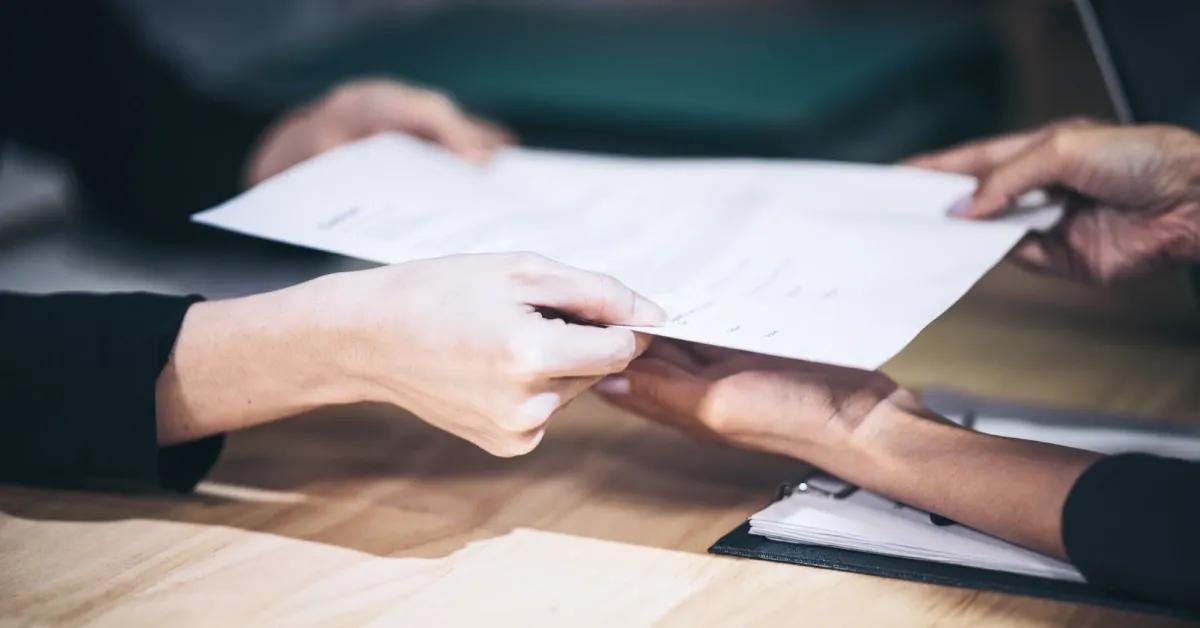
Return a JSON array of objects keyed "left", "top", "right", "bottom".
[{"left": 708, "top": 390, "right": 1200, "bottom": 621}]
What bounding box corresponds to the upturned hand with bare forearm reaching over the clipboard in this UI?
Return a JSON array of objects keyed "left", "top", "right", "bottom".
[{"left": 596, "top": 340, "right": 1098, "bottom": 557}]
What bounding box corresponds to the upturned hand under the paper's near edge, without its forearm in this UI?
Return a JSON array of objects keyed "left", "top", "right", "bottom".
[{"left": 596, "top": 340, "right": 907, "bottom": 463}]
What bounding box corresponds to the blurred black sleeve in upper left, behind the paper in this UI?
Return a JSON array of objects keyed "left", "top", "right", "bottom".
[{"left": 0, "top": 0, "right": 271, "bottom": 233}]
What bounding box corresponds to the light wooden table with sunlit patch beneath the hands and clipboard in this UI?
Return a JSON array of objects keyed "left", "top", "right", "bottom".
[{"left": 0, "top": 262, "right": 1200, "bottom": 626}]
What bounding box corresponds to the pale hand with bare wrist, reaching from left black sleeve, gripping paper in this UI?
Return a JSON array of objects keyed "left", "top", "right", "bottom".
[{"left": 158, "top": 255, "right": 665, "bottom": 456}]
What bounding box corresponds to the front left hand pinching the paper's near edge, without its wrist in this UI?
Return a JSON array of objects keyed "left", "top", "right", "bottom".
[{"left": 300, "top": 255, "right": 664, "bottom": 456}]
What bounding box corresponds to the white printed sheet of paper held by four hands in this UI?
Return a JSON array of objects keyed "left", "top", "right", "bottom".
[{"left": 194, "top": 134, "right": 1054, "bottom": 369}]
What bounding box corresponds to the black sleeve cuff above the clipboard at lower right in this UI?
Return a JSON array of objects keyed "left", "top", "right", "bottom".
[{"left": 1062, "top": 454, "right": 1200, "bottom": 609}]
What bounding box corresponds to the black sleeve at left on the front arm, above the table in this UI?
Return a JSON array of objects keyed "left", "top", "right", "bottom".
[{"left": 0, "top": 293, "right": 222, "bottom": 491}]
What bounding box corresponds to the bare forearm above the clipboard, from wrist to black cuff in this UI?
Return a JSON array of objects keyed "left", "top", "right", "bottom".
[{"left": 805, "top": 393, "right": 1099, "bottom": 557}]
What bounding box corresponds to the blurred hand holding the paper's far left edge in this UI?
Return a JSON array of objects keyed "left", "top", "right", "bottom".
[{"left": 245, "top": 79, "right": 512, "bottom": 186}]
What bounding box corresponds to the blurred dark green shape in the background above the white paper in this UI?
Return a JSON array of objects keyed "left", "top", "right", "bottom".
[{"left": 243, "top": 6, "right": 1006, "bottom": 160}]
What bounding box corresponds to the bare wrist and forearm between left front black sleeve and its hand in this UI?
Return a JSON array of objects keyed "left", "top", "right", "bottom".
[{"left": 156, "top": 280, "right": 355, "bottom": 445}]
